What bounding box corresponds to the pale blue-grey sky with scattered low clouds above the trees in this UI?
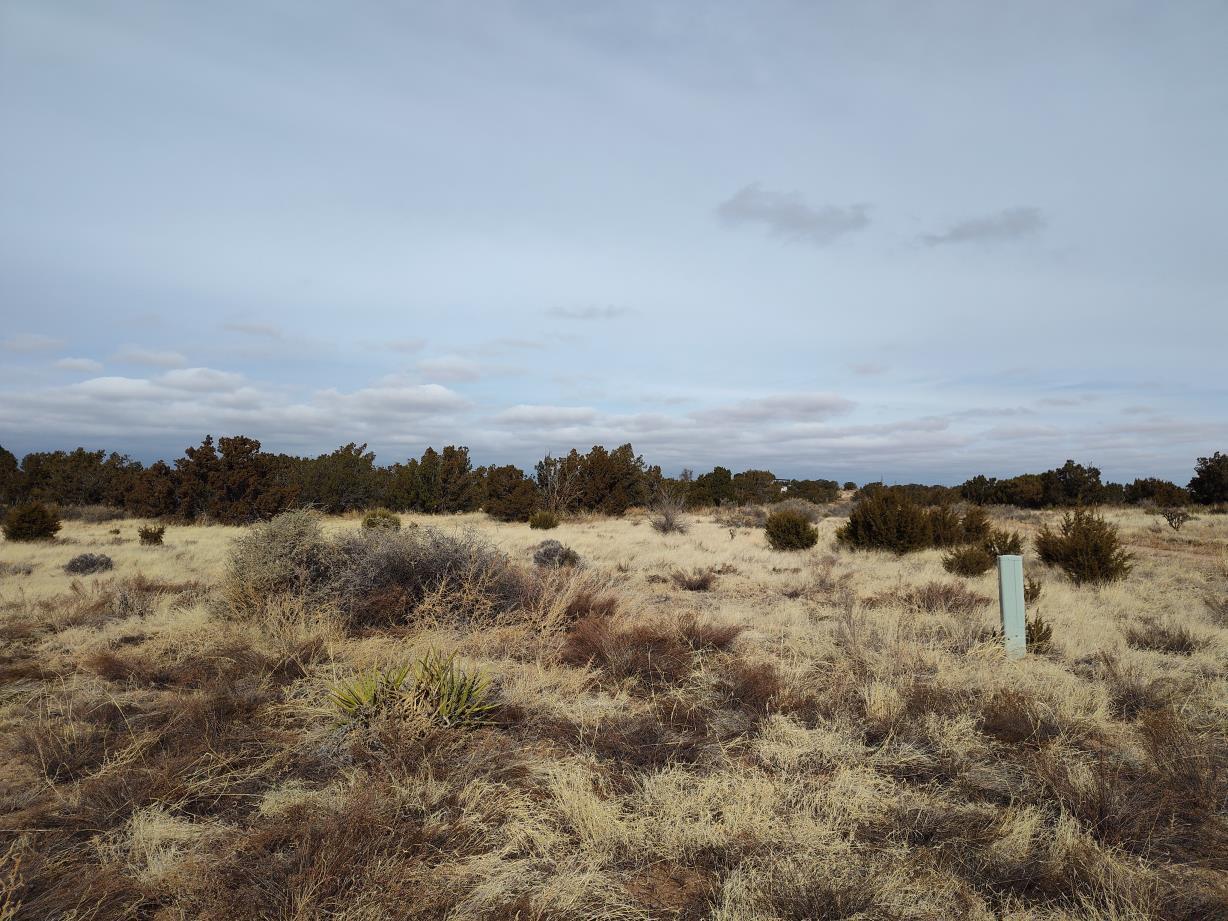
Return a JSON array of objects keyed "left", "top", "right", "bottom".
[{"left": 0, "top": 0, "right": 1228, "bottom": 483}]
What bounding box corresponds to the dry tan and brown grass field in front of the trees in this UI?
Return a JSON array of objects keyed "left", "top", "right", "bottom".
[{"left": 0, "top": 510, "right": 1228, "bottom": 921}]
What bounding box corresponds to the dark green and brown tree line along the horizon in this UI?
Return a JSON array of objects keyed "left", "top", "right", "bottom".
[{"left": 0, "top": 435, "right": 1228, "bottom": 524}]
